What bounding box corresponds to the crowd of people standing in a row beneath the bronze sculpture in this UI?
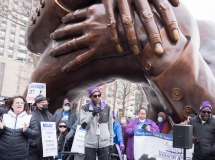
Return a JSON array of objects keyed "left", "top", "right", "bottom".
[{"left": 0, "top": 86, "right": 215, "bottom": 160}]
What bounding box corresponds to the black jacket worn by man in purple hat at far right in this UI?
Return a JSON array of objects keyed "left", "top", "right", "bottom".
[{"left": 188, "top": 116, "right": 215, "bottom": 160}]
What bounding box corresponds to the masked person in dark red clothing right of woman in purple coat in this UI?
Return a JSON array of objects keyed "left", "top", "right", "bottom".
[{"left": 156, "top": 112, "right": 170, "bottom": 134}]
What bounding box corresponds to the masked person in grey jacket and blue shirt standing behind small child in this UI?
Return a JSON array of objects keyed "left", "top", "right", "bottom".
[{"left": 54, "top": 98, "right": 80, "bottom": 143}]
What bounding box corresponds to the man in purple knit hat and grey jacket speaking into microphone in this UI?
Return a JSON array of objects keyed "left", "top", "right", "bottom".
[{"left": 80, "top": 86, "right": 113, "bottom": 160}]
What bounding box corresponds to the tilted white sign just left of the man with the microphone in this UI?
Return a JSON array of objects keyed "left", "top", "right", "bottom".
[{"left": 71, "top": 125, "right": 85, "bottom": 154}]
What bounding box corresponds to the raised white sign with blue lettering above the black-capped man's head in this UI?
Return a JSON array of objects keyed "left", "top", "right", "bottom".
[{"left": 26, "top": 83, "right": 46, "bottom": 103}]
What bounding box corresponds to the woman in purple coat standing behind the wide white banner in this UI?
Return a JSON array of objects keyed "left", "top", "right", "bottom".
[{"left": 126, "top": 108, "right": 159, "bottom": 160}]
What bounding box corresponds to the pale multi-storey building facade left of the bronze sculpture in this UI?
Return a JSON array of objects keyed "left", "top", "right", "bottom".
[{"left": 0, "top": 0, "right": 38, "bottom": 100}]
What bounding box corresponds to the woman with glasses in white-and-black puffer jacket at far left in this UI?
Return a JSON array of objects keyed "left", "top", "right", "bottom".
[{"left": 0, "top": 96, "right": 40, "bottom": 160}]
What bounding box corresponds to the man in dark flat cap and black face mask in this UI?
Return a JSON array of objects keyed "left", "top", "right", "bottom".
[{"left": 28, "top": 94, "right": 54, "bottom": 160}]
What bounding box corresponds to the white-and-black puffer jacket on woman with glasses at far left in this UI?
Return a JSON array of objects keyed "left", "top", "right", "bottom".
[{"left": 0, "top": 110, "right": 40, "bottom": 160}]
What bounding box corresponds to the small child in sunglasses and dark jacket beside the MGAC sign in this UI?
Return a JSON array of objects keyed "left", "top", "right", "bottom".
[{"left": 55, "top": 121, "right": 68, "bottom": 160}]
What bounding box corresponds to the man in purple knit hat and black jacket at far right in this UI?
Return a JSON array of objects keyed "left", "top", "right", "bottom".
[{"left": 188, "top": 101, "right": 215, "bottom": 160}]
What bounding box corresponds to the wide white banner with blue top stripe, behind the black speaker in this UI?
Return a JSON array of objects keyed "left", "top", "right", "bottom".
[{"left": 134, "top": 129, "right": 193, "bottom": 160}]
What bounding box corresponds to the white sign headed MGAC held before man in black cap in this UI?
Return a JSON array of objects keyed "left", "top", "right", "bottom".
[{"left": 40, "top": 122, "right": 58, "bottom": 157}]
